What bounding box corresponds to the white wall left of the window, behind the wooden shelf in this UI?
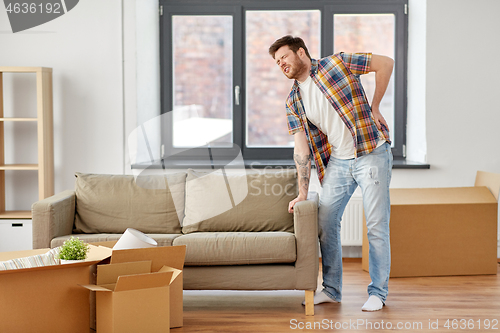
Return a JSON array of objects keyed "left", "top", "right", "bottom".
[{"left": 0, "top": 0, "right": 124, "bottom": 209}]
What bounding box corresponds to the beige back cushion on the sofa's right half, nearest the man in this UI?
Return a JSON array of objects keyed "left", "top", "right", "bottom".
[{"left": 182, "top": 169, "right": 297, "bottom": 234}]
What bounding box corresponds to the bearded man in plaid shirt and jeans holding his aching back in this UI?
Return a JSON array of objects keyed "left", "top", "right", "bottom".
[{"left": 269, "top": 36, "right": 394, "bottom": 311}]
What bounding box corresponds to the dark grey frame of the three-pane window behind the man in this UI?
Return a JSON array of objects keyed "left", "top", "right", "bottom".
[{"left": 159, "top": 0, "right": 408, "bottom": 165}]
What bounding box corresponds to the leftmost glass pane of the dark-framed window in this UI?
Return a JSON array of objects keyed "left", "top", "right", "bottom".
[{"left": 171, "top": 15, "right": 233, "bottom": 148}]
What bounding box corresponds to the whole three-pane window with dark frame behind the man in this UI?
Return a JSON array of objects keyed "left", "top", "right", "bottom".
[{"left": 160, "top": 0, "right": 408, "bottom": 164}]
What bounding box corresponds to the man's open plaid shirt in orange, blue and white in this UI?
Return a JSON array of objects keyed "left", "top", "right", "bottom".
[{"left": 286, "top": 53, "right": 390, "bottom": 183}]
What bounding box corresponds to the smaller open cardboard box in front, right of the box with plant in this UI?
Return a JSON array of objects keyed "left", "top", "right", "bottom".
[{"left": 82, "top": 261, "right": 182, "bottom": 333}]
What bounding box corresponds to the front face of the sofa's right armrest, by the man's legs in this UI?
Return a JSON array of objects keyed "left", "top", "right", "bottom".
[{"left": 293, "top": 192, "right": 319, "bottom": 290}]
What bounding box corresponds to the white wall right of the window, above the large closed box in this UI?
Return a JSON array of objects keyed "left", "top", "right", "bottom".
[{"left": 392, "top": 0, "right": 500, "bottom": 187}]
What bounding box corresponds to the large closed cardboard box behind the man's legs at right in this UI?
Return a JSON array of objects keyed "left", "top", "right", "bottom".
[{"left": 362, "top": 186, "right": 498, "bottom": 277}]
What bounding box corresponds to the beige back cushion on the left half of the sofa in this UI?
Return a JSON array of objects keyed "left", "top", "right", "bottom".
[{"left": 75, "top": 173, "right": 186, "bottom": 234}]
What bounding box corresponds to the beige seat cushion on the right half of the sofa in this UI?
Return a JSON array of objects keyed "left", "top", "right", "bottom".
[{"left": 173, "top": 231, "right": 297, "bottom": 266}]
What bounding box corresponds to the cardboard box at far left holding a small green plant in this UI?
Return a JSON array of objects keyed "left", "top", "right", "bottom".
[{"left": 0, "top": 246, "right": 111, "bottom": 333}]
